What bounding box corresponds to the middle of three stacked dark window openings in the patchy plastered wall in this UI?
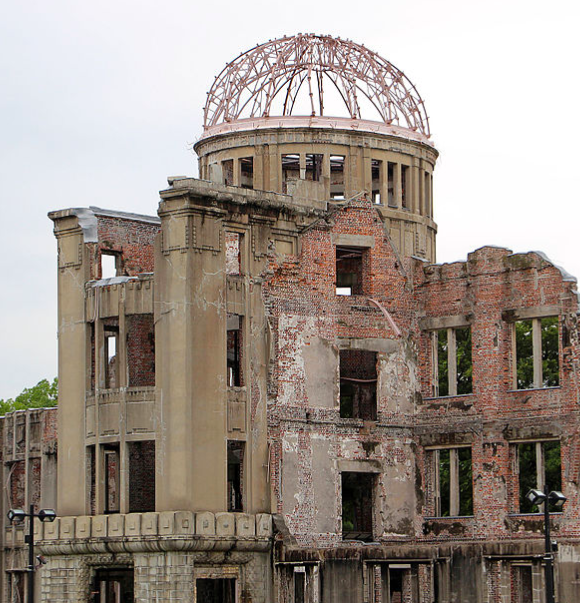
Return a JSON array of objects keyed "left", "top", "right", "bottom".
[{"left": 340, "top": 350, "right": 377, "bottom": 421}]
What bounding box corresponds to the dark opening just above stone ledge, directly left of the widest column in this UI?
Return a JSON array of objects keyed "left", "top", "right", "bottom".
[{"left": 128, "top": 440, "right": 155, "bottom": 513}]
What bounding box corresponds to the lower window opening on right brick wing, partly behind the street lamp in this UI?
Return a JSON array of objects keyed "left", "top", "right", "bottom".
[{"left": 516, "top": 440, "right": 562, "bottom": 513}]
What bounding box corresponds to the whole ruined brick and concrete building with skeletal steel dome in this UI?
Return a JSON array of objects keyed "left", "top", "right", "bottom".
[{"left": 2, "top": 35, "right": 580, "bottom": 603}]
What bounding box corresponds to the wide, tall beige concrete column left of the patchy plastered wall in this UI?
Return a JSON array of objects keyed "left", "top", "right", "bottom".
[{"left": 155, "top": 197, "right": 227, "bottom": 512}]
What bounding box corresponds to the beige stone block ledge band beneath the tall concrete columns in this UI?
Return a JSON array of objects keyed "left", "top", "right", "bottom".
[{"left": 24, "top": 511, "right": 273, "bottom": 555}]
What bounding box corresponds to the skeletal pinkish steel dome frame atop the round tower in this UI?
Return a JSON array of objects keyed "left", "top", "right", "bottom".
[{"left": 204, "top": 34, "right": 430, "bottom": 137}]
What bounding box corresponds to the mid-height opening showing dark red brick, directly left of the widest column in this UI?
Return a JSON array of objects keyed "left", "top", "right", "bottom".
[{"left": 127, "top": 314, "right": 155, "bottom": 387}]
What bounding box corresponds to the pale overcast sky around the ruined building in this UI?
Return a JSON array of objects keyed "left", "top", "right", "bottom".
[{"left": 0, "top": 0, "right": 580, "bottom": 398}]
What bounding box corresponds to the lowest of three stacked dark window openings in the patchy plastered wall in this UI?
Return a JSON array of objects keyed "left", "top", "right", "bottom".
[{"left": 342, "top": 472, "right": 375, "bottom": 541}]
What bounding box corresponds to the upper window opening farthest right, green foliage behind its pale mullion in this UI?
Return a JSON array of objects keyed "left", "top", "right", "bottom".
[{"left": 514, "top": 316, "right": 560, "bottom": 389}]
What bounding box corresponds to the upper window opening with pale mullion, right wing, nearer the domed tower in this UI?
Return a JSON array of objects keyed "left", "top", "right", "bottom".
[{"left": 433, "top": 327, "right": 473, "bottom": 396}]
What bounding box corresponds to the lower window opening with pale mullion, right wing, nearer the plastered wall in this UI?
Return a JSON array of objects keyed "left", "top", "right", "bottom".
[{"left": 433, "top": 448, "right": 473, "bottom": 517}]
